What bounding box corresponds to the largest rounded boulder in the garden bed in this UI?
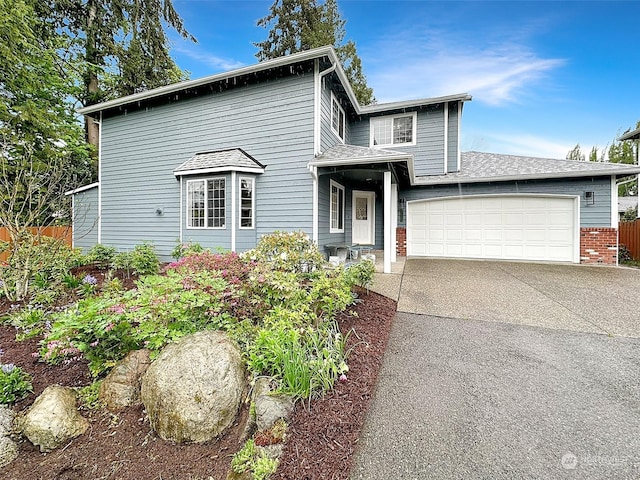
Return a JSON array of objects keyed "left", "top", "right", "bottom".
[{"left": 141, "top": 331, "right": 245, "bottom": 442}]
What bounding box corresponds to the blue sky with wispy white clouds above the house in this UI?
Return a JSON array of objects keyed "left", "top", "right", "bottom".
[{"left": 170, "top": 0, "right": 640, "bottom": 158}]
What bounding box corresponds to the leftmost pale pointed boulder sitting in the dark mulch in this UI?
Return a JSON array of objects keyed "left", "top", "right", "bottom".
[{"left": 20, "top": 385, "right": 89, "bottom": 452}]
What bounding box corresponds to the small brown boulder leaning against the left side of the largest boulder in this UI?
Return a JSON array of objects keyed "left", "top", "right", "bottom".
[{"left": 99, "top": 350, "right": 151, "bottom": 410}]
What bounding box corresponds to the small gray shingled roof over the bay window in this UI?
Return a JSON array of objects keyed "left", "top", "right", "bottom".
[{"left": 173, "top": 148, "right": 265, "bottom": 177}]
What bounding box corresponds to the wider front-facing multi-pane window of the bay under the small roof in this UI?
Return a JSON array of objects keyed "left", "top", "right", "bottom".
[{"left": 187, "top": 178, "right": 226, "bottom": 228}]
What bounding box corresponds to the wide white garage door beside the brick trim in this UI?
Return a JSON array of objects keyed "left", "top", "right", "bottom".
[{"left": 407, "top": 195, "right": 579, "bottom": 262}]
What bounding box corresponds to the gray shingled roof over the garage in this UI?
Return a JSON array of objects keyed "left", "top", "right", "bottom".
[{"left": 415, "top": 152, "right": 640, "bottom": 185}]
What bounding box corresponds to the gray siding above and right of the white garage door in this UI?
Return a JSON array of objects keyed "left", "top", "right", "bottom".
[{"left": 398, "top": 177, "right": 611, "bottom": 227}]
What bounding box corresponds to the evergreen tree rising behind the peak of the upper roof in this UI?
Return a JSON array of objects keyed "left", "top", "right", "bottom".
[{"left": 254, "top": 0, "right": 375, "bottom": 105}]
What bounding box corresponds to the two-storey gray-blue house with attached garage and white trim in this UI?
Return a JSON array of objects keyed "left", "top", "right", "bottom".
[{"left": 69, "top": 47, "right": 640, "bottom": 271}]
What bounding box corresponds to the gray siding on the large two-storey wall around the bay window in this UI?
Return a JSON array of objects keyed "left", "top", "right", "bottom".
[{"left": 101, "top": 72, "right": 313, "bottom": 257}]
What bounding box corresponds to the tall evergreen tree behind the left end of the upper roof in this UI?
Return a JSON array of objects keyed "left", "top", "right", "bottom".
[{"left": 47, "top": 0, "right": 195, "bottom": 145}]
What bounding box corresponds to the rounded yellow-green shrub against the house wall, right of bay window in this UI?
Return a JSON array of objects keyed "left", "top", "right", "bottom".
[{"left": 246, "top": 232, "right": 325, "bottom": 274}]
